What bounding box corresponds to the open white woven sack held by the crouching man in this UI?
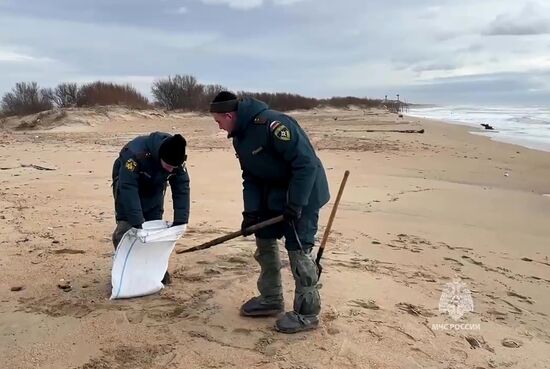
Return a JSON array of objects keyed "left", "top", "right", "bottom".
[{"left": 111, "top": 220, "right": 187, "bottom": 300}]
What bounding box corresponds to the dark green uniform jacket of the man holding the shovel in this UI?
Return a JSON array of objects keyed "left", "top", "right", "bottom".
[{"left": 230, "top": 98, "right": 330, "bottom": 213}]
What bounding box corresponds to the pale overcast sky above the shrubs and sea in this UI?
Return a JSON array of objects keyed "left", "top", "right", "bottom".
[{"left": 0, "top": 0, "right": 550, "bottom": 105}]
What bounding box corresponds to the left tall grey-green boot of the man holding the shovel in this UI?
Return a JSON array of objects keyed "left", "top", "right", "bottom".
[{"left": 241, "top": 238, "right": 284, "bottom": 316}]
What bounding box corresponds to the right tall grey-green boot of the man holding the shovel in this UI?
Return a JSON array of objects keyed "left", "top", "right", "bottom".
[{"left": 276, "top": 249, "right": 321, "bottom": 333}]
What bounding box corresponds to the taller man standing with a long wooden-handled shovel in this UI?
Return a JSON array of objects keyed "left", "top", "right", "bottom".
[{"left": 210, "top": 91, "right": 330, "bottom": 333}]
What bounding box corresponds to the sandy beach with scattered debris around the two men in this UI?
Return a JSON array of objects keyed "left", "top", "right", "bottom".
[{"left": 0, "top": 108, "right": 550, "bottom": 369}]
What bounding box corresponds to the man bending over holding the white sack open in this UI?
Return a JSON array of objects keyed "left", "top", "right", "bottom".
[{"left": 112, "top": 132, "right": 189, "bottom": 284}]
